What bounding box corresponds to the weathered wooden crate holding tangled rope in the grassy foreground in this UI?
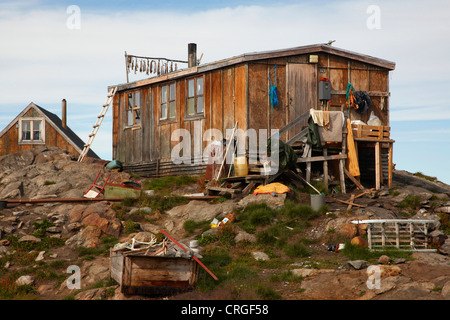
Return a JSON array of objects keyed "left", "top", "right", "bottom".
[{"left": 110, "top": 250, "right": 199, "bottom": 295}]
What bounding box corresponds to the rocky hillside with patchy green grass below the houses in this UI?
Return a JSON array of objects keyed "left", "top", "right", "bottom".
[{"left": 0, "top": 147, "right": 450, "bottom": 300}]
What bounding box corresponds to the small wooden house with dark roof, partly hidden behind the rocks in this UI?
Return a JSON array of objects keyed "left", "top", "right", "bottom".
[{"left": 0, "top": 100, "right": 99, "bottom": 158}]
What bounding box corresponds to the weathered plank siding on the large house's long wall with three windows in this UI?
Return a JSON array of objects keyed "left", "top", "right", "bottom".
[{"left": 113, "top": 64, "right": 248, "bottom": 175}]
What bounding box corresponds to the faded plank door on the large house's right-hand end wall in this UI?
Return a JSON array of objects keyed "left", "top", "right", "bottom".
[{"left": 286, "top": 63, "right": 317, "bottom": 139}]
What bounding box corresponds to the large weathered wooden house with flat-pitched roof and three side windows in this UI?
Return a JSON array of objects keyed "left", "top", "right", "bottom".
[{"left": 110, "top": 44, "right": 395, "bottom": 189}]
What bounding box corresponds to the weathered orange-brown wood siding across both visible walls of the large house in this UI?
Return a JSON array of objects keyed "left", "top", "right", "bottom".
[{"left": 113, "top": 52, "right": 390, "bottom": 175}]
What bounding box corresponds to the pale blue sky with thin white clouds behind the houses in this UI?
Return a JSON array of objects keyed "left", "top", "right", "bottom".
[{"left": 0, "top": 0, "right": 450, "bottom": 183}]
